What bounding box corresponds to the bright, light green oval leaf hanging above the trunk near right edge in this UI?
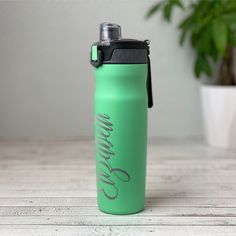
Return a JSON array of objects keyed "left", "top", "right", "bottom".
[{"left": 212, "top": 17, "right": 228, "bottom": 55}]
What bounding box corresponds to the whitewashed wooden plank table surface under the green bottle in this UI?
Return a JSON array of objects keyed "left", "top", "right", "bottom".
[{"left": 0, "top": 138, "right": 236, "bottom": 236}]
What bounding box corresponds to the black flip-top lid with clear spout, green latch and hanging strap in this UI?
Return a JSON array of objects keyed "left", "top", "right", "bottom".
[{"left": 90, "top": 23, "right": 153, "bottom": 108}]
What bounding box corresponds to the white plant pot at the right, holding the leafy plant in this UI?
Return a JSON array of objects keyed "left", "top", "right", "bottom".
[{"left": 201, "top": 85, "right": 236, "bottom": 149}]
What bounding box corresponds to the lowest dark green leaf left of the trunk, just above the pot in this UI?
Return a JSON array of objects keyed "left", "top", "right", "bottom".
[{"left": 194, "top": 54, "right": 212, "bottom": 78}]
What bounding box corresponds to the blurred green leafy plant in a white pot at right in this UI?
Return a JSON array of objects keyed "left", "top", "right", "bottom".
[{"left": 146, "top": 0, "right": 236, "bottom": 148}]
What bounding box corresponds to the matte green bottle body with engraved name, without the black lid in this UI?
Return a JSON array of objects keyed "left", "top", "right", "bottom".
[{"left": 95, "top": 64, "right": 148, "bottom": 214}]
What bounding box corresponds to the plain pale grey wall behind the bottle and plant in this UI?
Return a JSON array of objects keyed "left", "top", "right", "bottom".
[{"left": 0, "top": 0, "right": 202, "bottom": 139}]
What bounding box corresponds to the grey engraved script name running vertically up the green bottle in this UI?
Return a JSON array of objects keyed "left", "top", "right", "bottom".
[{"left": 95, "top": 113, "right": 130, "bottom": 200}]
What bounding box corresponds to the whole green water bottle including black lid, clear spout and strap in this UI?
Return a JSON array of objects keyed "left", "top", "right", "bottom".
[{"left": 91, "top": 23, "right": 153, "bottom": 214}]
